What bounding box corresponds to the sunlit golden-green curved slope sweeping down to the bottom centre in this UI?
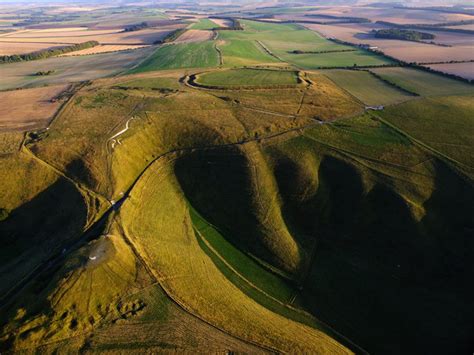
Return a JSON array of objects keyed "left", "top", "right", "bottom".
[{"left": 122, "top": 159, "right": 352, "bottom": 353}]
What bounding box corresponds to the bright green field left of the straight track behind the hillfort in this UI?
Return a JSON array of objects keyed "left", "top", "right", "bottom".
[{"left": 130, "top": 41, "right": 219, "bottom": 73}]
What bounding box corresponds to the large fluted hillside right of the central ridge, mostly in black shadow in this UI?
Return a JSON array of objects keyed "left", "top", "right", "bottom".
[{"left": 264, "top": 117, "right": 474, "bottom": 353}]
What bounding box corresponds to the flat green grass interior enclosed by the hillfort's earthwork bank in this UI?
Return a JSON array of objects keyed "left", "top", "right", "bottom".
[{"left": 194, "top": 68, "right": 301, "bottom": 88}]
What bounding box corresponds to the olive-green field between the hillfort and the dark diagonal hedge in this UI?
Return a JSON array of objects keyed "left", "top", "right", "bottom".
[{"left": 321, "top": 69, "right": 413, "bottom": 106}]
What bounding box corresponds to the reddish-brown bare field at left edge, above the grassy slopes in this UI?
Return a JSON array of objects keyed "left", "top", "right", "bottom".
[{"left": 0, "top": 85, "right": 68, "bottom": 131}]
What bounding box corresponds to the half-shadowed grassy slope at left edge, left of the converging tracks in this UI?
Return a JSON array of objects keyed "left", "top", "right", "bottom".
[{"left": 0, "top": 133, "right": 103, "bottom": 300}]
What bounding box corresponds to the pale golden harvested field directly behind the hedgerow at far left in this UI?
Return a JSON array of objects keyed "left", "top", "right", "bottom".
[{"left": 0, "top": 25, "right": 182, "bottom": 45}]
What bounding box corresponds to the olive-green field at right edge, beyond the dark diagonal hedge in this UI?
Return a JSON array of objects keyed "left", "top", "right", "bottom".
[{"left": 371, "top": 68, "right": 474, "bottom": 96}]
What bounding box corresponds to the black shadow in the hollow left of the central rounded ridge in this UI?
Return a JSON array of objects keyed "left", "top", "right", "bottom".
[{"left": 175, "top": 148, "right": 286, "bottom": 270}]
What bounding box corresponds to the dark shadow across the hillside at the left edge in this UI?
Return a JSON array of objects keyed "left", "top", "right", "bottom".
[{"left": 0, "top": 178, "right": 87, "bottom": 344}]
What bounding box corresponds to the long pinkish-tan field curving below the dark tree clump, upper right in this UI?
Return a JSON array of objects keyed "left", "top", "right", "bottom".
[{"left": 304, "top": 24, "right": 474, "bottom": 63}]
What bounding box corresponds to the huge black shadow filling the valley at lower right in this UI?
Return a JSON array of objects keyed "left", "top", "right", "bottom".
[{"left": 301, "top": 158, "right": 474, "bottom": 354}]
